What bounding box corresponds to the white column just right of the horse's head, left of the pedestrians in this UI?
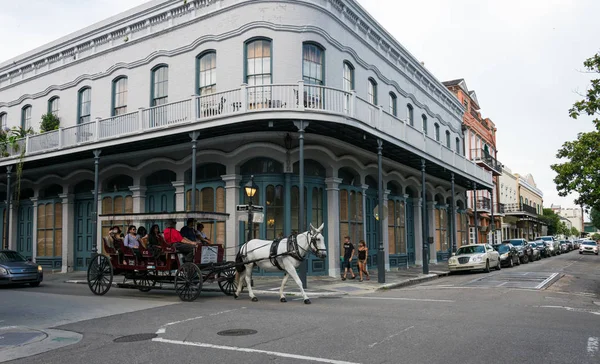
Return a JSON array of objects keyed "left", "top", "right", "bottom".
[{"left": 325, "top": 177, "right": 342, "bottom": 277}]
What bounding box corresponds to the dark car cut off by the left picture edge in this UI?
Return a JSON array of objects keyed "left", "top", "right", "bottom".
[{"left": 0, "top": 250, "right": 44, "bottom": 287}]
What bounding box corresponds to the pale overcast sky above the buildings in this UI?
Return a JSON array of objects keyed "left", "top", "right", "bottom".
[{"left": 0, "top": 0, "right": 600, "bottom": 207}]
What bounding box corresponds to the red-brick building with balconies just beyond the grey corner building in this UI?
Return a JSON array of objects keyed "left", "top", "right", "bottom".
[{"left": 443, "top": 79, "right": 504, "bottom": 244}]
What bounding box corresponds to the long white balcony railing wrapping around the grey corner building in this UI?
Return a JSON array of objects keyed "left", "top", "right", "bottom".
[{"left": 5, "top": 81, "right": 492, "bottom": 184}]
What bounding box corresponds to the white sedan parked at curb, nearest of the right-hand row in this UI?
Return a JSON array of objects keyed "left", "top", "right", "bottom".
[{"left": 448, "top": 244, "right": 501, "bottom": 273}]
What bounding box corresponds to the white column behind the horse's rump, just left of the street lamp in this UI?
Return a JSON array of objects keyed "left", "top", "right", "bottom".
[{"left": 221, "top": 174, "right": 242, "bottom": 261}]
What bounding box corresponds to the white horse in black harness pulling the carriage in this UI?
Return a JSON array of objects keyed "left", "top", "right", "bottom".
[{"left": 233, "top": 224, "right": 327, "bottom": 304}]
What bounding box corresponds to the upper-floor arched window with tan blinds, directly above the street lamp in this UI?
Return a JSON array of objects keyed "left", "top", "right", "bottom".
[{"left": 245, "top": 38, "right": 272, "bottom": 86}]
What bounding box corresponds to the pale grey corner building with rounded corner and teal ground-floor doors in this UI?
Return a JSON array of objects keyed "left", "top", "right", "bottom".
[{"left": 0, "top": 0, "right": 493, "bottom": 276}]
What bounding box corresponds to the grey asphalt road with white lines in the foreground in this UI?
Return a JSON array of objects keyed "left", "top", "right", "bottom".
[{"left": 0, "top": 252, "right": 600, "bottom": 364}]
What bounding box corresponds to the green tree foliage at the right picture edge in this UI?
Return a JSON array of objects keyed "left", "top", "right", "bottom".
[{"left": 551, "top": 53, "right": 600, "bottom": 210}]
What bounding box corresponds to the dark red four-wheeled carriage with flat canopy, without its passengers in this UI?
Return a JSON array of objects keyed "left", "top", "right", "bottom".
[{"left": 87, "top": 212, "right": 237, "bottom": 301}]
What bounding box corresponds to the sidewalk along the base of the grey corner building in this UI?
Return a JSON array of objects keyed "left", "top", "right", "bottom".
[{"left": 51, "top": 263, "right": 448, "bottom": 297}]
